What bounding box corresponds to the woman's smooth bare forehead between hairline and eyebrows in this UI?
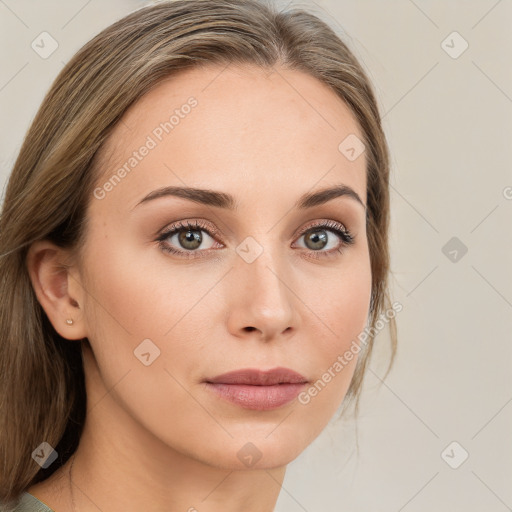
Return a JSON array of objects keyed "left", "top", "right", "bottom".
[{"left": 91, "top": 65, "right": 366, "bottom": 210}]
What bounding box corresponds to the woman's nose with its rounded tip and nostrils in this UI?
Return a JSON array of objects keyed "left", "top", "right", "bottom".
[{"left": 226, "top": 245, "right": 299, "bottom": 341}]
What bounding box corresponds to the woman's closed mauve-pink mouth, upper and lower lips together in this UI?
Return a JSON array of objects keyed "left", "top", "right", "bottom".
[{"left": 205, "top": 367, "right": 308, "bottom": 411}]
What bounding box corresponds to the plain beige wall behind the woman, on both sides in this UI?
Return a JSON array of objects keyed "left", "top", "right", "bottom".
[{"left": 0, "top": 0, "right": 512, "bottom": 512}]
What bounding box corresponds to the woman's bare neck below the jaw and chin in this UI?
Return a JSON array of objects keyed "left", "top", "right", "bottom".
[{"left": 72, "top": 420, "right": 286, "bottom": 512}]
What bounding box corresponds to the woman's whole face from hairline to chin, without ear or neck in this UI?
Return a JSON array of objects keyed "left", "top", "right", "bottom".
[{"left": 75, "top": 66, "right": 371, "bottom": 468}]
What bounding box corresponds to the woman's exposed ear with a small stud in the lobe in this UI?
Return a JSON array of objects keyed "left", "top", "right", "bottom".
[{"left": 26, "top": 240, "right": 87, "bottom": 340}]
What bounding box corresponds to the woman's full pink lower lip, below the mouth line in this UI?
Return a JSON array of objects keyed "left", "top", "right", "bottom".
[{"left": 206, "top": 382, "right": 306, "bottom": 411}]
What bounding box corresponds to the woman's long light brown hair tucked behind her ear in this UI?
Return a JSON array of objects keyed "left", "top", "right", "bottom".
[{"left": 0, "top": 0, "right": 396, "bottom": 501}]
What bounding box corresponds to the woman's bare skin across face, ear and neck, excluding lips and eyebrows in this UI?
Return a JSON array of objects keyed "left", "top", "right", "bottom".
[{"left": 27, "top": 65, "right": 371, "bottom": 512}]
